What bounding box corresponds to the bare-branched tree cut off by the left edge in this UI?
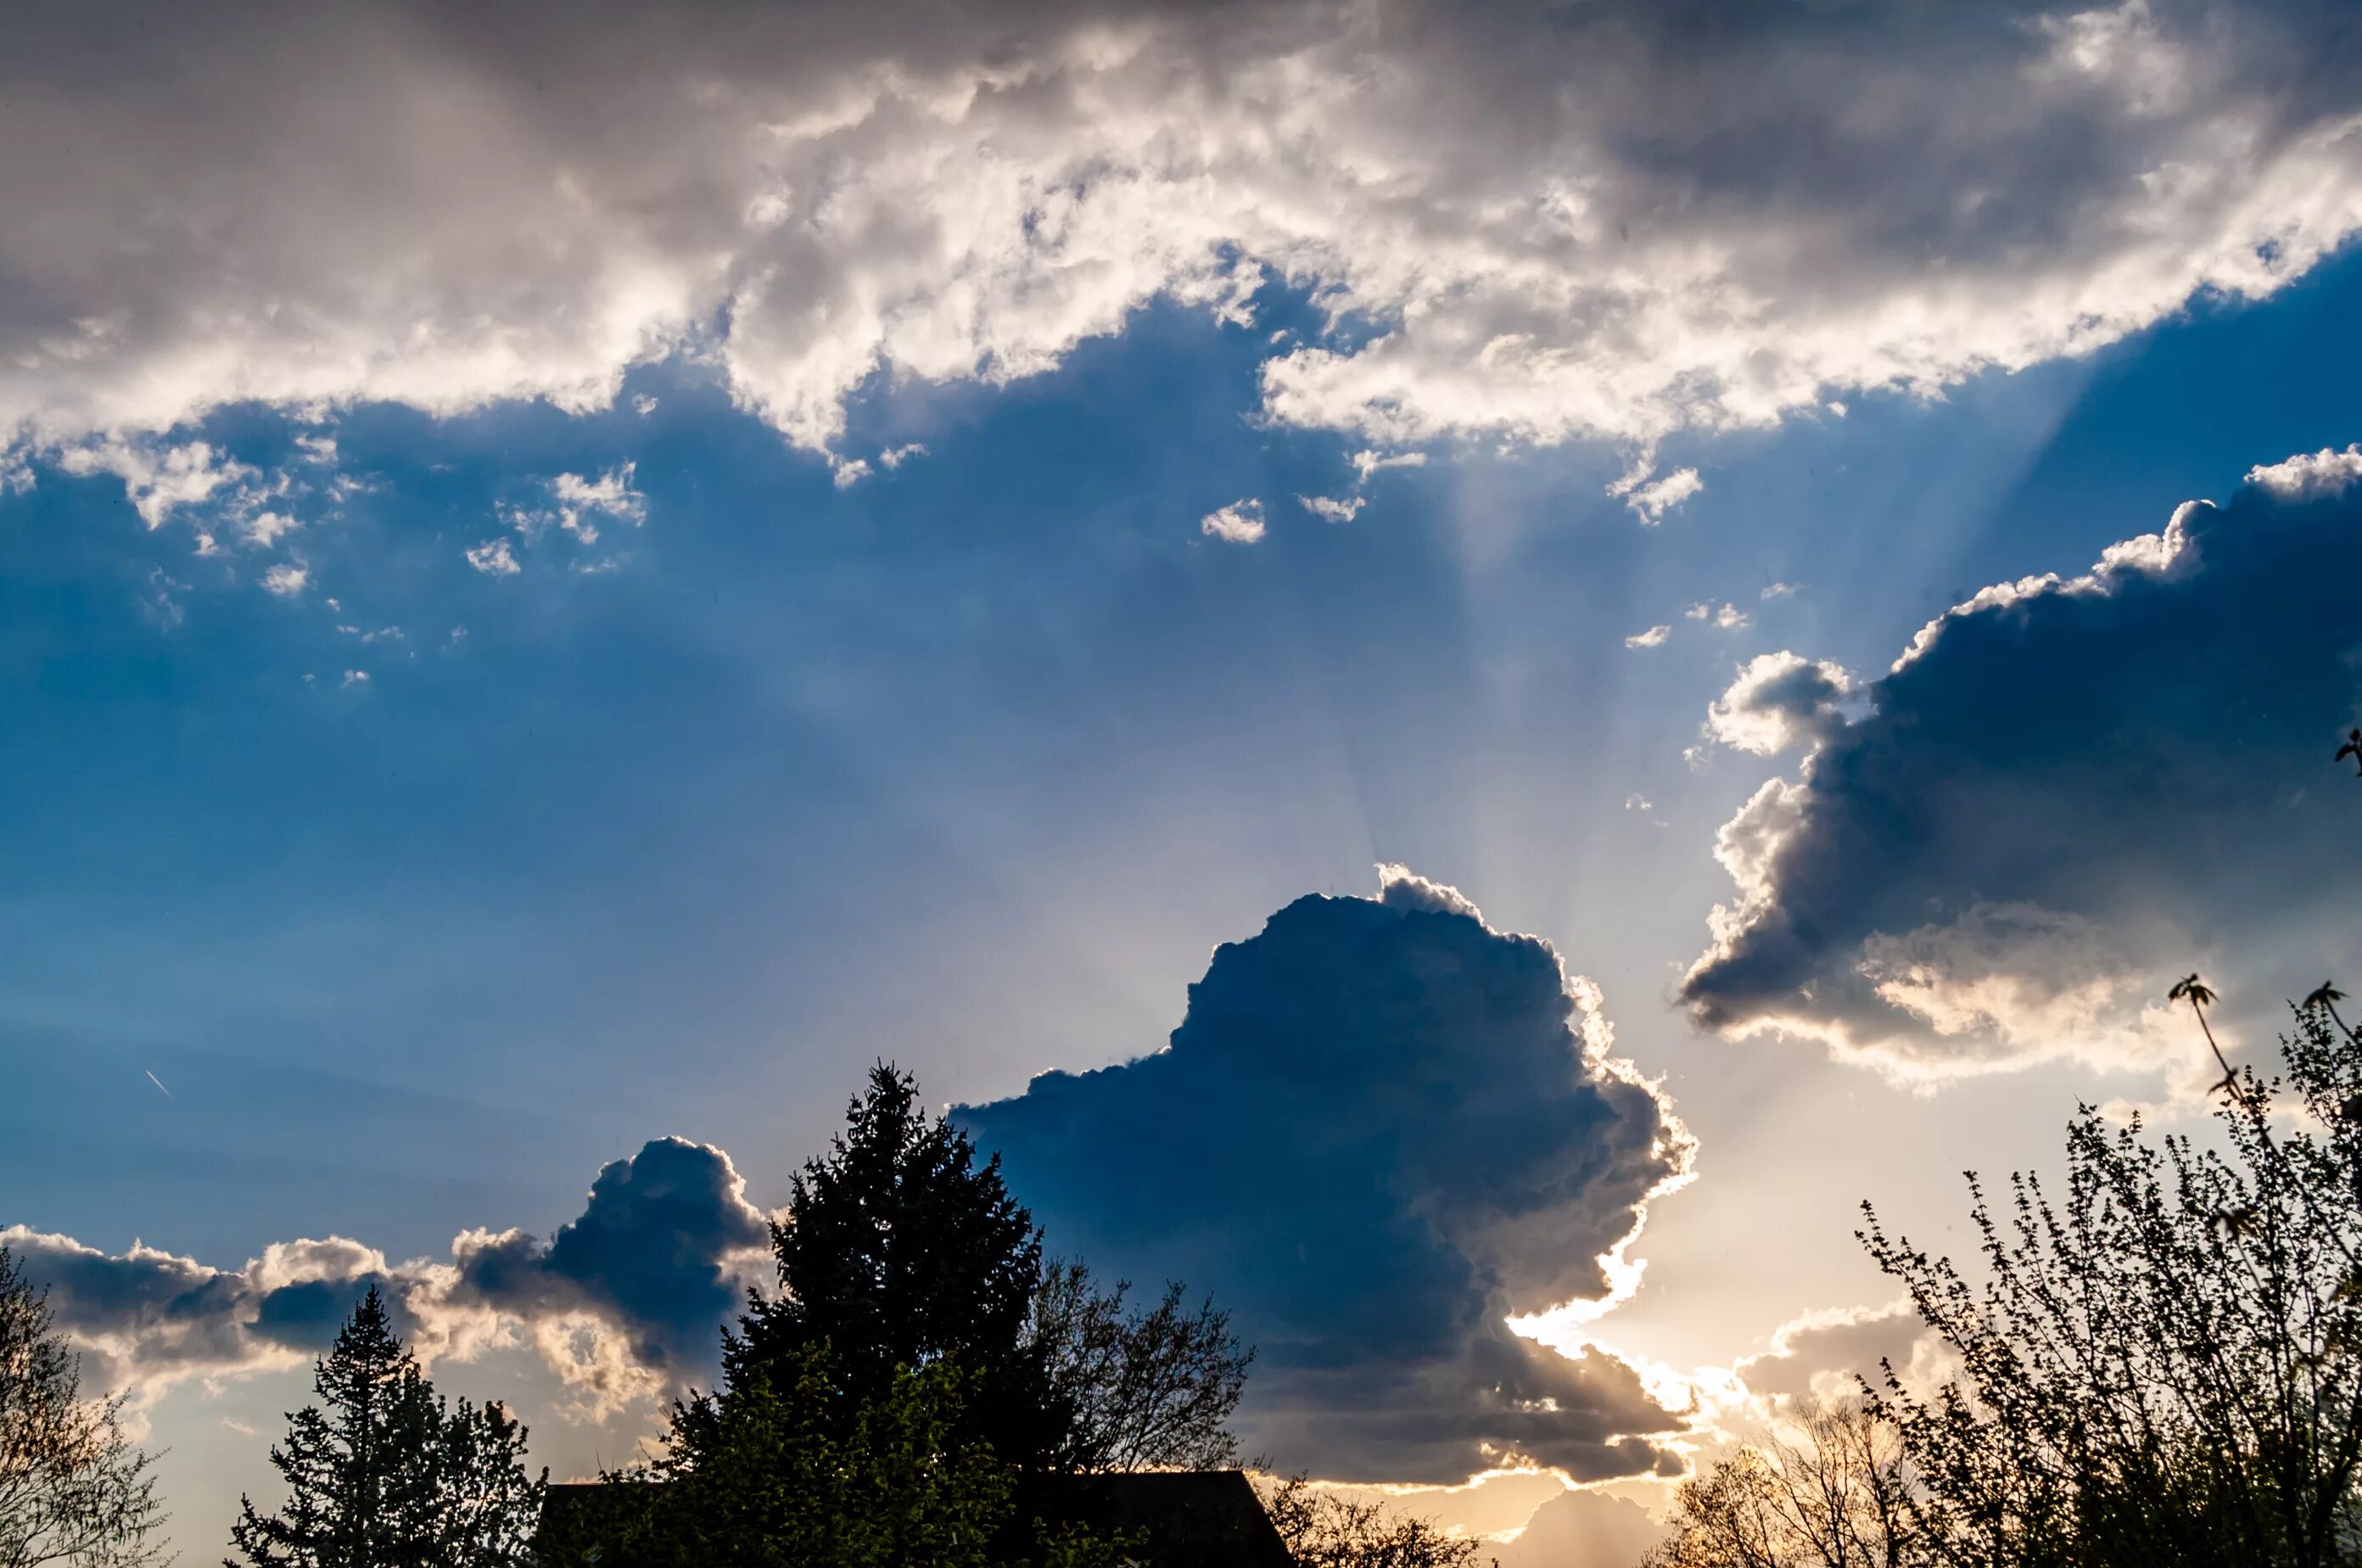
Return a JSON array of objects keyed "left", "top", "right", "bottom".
[{"left": 0, "top": 1246, "right": 165, "bottom": 1568}]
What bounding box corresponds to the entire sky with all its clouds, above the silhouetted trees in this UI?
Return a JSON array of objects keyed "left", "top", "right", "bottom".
[{"left": 0, "top": 0, "right": 2362, "bottom": 1568}]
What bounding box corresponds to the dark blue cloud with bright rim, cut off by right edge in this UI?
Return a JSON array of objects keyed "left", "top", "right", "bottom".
[{"left": 1682, "top": 453, "right": 2362, "bottom": 1089}]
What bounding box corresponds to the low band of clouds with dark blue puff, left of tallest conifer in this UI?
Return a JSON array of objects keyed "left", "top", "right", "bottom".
[{"left": 0, "top": 1138, "right": 770, "bottom": 1412}]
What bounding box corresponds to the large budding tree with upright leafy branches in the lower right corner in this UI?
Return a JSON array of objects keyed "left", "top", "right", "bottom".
[{"left": 1864, "top": 977, "right": 2362, "bottom": 1568}]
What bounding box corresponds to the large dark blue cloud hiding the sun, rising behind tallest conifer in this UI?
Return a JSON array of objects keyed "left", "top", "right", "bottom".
[{"left": 957, "top": 866, "right": 1691, "bottom": 1481}]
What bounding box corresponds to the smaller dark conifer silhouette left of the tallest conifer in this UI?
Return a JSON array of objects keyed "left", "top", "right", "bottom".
[{"left": 227, "top": 1287, "right": 546, "bottom": 1568}]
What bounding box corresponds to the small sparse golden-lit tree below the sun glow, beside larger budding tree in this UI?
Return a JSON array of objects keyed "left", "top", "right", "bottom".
[{"left": 1646, "top": 1398, "right": 1928, "bottom": 1568}]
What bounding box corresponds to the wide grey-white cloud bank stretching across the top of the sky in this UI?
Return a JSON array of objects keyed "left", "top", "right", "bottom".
[{"left": 0, "top": 0, "right": 2362, "bottom": 465}]
